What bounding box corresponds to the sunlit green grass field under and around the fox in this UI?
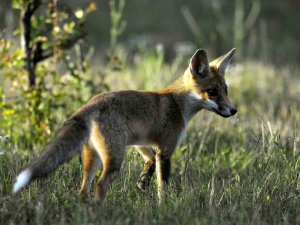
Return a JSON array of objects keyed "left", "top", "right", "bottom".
[{"left": 0, "top": 55, "right": 300, "bottom": 225}]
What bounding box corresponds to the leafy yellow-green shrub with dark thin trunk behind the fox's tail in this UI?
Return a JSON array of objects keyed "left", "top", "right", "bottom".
[{"left": 0, "top": 0, "right": 103, "bottom": 145}]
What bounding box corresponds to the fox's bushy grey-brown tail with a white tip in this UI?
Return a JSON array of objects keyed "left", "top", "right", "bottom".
[{"left": 13, "top": 118, "right": 90, "bottom": 193}]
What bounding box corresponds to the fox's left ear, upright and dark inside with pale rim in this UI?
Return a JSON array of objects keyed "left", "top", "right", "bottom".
[{"left": 190, "top": 49, "right": 209, "bottom": 78}]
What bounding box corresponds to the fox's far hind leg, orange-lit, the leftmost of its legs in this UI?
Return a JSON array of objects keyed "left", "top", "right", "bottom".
[{"left": 79, "top": 144, "right": 102, "bottom": 197}]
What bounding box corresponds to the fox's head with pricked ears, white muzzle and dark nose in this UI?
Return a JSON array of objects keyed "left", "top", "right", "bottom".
[{"left": 184, "top": 49, "right": 237, "bottom": 117}]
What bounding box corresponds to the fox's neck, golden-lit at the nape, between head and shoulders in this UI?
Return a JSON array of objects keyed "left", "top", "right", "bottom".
[{"left": 159, "top": 70, "right": 205, "bottom": 125}]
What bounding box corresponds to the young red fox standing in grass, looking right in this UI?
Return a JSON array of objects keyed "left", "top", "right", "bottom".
[{"left": 13, "top": 49, "right": 237, "bottom": 202}]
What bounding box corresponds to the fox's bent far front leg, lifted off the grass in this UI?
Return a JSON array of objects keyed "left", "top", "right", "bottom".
[{"left": 137, "top": 146, "right": 155, "bottom": 191}]
